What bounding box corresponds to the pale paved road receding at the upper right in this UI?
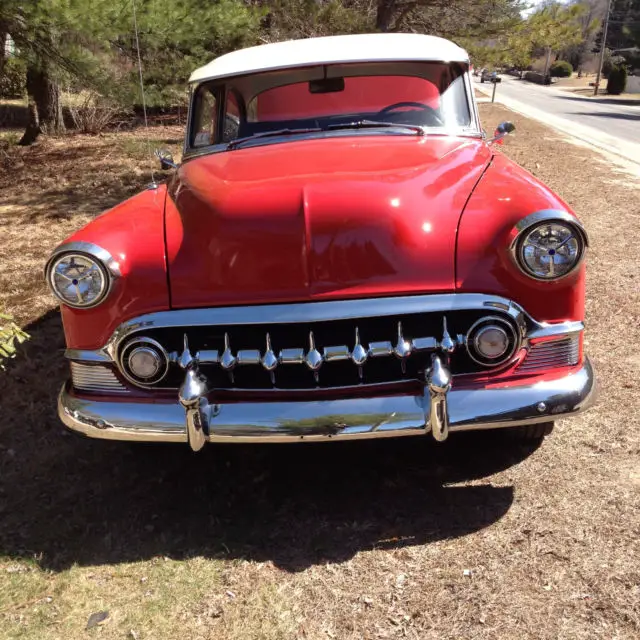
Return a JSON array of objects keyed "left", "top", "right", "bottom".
[{"left": 474, "top": 76, "right": 640, "bottom": 162}]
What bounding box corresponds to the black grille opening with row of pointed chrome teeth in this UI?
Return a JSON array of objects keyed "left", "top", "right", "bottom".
[{"left": 123, "top": 308, "right": 518, "bottom": 390}]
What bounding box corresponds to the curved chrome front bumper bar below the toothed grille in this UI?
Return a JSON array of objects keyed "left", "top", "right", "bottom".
[{"left": 58, "top": 359, "right": 594, "bottom": 449}]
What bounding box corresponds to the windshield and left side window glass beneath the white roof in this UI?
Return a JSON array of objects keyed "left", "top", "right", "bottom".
[{"left": 189, "top": 62, "right": 472, "bottom": 150}]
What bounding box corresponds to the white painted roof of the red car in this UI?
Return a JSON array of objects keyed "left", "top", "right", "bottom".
[{"left": 189, "top": 33, "right": 469, "bottom": 82}]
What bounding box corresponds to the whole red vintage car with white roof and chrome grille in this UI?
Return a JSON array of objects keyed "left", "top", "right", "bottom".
[{"left": 46, "top": 34, "right": 594, "bottom": 450}]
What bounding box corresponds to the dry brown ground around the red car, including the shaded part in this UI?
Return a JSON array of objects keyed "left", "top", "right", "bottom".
[{"left": 0, "top": 104, "right": 640, "bottom": 640}]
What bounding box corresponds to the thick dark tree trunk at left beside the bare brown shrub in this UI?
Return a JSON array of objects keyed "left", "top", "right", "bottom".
[{"left": 19, "top": 61, "right": 65, "bottom": 145}]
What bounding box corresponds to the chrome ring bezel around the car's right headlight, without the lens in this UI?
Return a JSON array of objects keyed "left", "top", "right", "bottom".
[{"left": 509, "top": 209, "right": 589, "bottom": 282}]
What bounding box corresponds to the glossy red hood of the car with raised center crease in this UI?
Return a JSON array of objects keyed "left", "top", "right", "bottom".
[{"left": 166, "top": 136, "right": 491, "bottom": 307}]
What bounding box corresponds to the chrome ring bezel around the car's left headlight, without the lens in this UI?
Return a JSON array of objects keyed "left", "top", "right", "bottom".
[{"left": 45, "top": 242, "right": 121, "bottom": 309}]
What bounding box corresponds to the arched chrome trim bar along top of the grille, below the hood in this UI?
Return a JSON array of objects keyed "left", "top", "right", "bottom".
[{"left": 65, "top": 293, "right": 584, "bottom": 362}]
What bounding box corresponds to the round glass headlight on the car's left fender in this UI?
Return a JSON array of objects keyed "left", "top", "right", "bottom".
[{"left": 48, "top": 253, "right": 110, "bottom": 309}]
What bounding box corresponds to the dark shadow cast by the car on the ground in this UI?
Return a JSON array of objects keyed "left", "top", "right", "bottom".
[{"left": 0, "top": 311, "right": 535, "bottom": 571}]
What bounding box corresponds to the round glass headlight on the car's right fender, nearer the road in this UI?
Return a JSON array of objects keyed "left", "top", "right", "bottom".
[{"left": 517, "top": 221, "right": 584, "bottom": 280}]
